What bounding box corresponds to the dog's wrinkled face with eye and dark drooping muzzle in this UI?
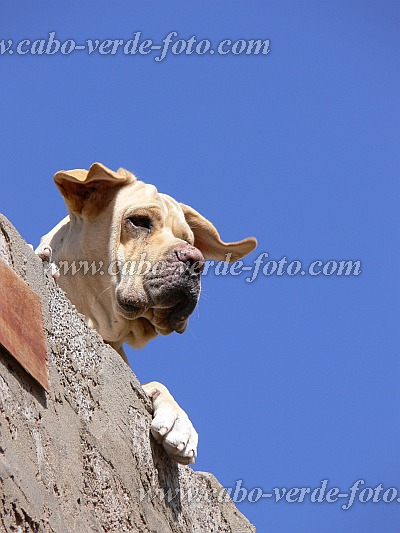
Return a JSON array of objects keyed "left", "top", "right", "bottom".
[{"left": 115, "top": 200, "right": 204, "bottom": 335}]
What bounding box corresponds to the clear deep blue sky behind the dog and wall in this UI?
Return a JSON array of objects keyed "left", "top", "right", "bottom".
[{"left": 0, "top": 1, "right": 400, "bottom": 533}]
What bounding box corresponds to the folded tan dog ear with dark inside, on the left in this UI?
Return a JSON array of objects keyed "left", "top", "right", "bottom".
[{"left": 54, "top": 163, "right": 136, "bottom": 215}]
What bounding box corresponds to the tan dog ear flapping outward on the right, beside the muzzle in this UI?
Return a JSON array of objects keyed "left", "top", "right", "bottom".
[{"left": 180, "top": 204, "right": 257, "bottom": 263}]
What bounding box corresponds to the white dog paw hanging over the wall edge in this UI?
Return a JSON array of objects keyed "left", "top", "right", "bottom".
[{"left": 143, "top": 382, "right": 199, "bottom": 465}]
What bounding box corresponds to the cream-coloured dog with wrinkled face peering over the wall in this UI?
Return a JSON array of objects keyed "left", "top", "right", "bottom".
[{"left": 36, "top": 163, "right": 257, "bottom": 464}]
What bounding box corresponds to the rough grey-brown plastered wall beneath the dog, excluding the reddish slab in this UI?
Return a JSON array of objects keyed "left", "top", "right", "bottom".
[{"left": 0, "top": 216, "right": 255, "bottom": 533}]
